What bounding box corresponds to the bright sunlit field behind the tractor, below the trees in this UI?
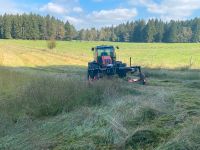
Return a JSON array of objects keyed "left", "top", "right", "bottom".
[{"left": 0, "top": 40, "right": 200, "bottom": 68}]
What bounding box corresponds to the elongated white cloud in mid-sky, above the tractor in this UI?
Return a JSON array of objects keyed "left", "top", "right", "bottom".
[{"left": 88, "top": 8, "right": 137, "bottom": 22}]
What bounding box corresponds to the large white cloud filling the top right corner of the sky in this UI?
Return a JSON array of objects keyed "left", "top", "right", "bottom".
[{"left": 130, "top": 0, "right": 200, "bottom": 20}]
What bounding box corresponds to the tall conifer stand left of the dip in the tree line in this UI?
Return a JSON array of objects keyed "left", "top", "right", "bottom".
[{"left": 0, "top": 14, "right": 76, "bottom": 40}]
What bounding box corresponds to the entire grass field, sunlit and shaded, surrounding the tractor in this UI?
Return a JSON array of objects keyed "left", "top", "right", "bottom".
[{"left": 0, "top": 40, "right": 200, "bottom": 150}]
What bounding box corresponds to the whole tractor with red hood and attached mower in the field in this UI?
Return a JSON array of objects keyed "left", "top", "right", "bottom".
[{"left": 87, "top": 45, "right": 146, "bottom": 84}]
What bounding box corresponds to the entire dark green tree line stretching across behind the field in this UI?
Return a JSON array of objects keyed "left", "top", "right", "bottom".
[{"left": 0, "top": 14, "right": 200, "bottom": 43}]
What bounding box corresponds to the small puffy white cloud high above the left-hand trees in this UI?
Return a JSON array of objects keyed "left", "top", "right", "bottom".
[{"left": 40, "top": 2, "right": 68, "bottom": 14}]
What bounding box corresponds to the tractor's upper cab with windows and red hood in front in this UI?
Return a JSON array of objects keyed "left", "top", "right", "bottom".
[{"left": 92, "top": 45, "right": 116, "bottom": 66}]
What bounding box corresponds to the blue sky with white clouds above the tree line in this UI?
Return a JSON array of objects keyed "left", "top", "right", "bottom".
[{"left": 0, "top": 0, "right": 200, "bottom": 29}]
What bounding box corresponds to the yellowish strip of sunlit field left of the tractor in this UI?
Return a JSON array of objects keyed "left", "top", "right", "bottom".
[{"left": 0, "top": 41, "right": 87, "bottom": 67}]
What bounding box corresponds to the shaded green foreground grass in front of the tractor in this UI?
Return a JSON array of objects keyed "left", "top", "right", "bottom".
[{"left": 0, "top": 68, "right": 200, "bottom": 150}]
